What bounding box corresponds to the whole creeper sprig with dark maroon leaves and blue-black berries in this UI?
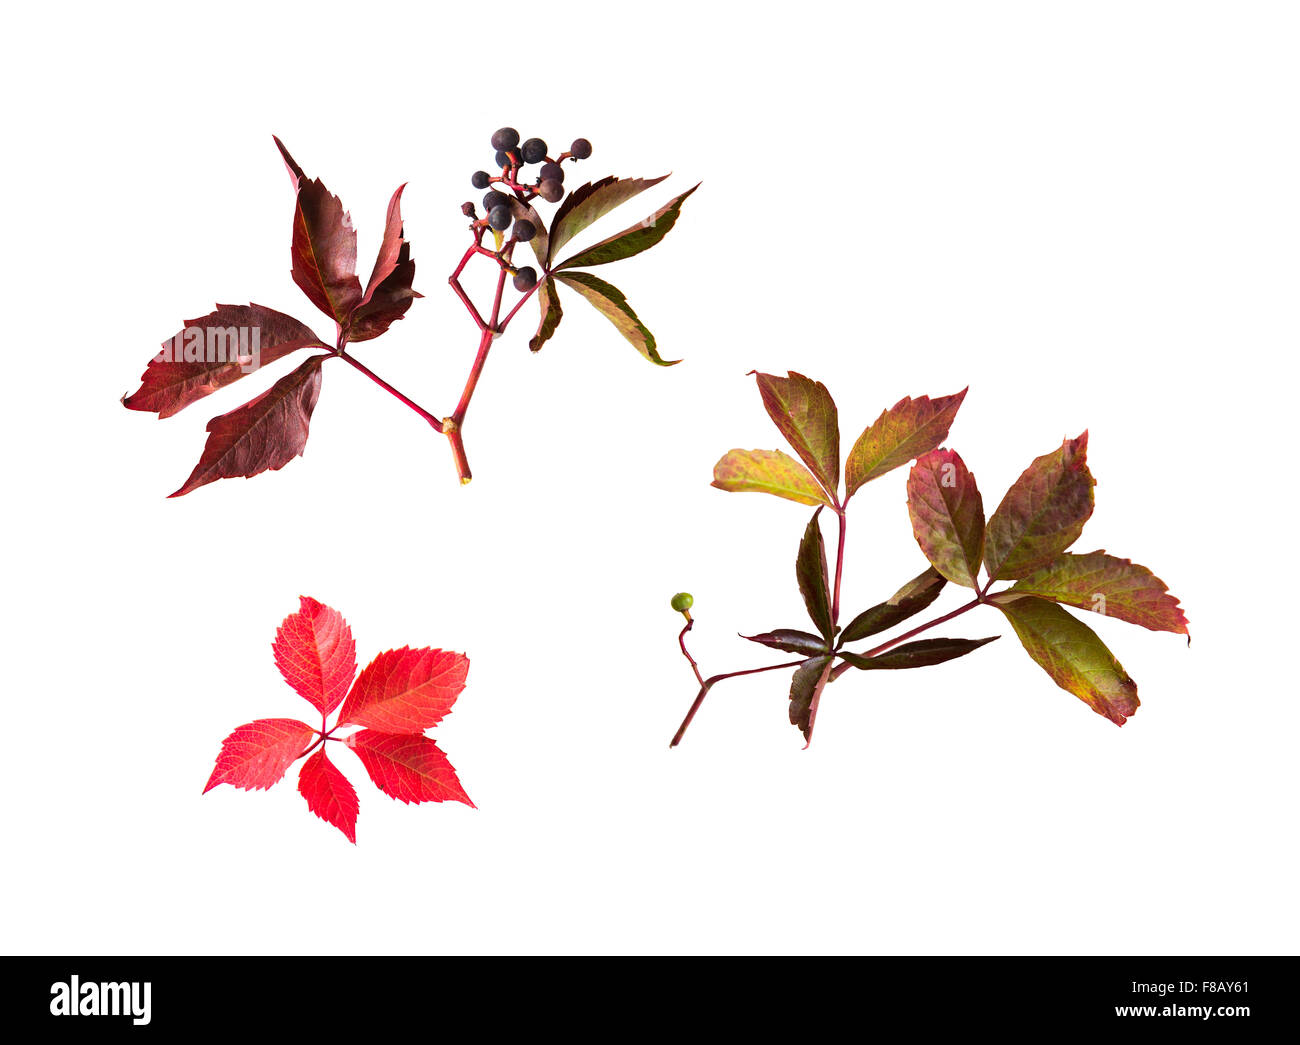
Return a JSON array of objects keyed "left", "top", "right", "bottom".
[{"left": 122, "top": 127, "right": 699, "bottom": 497}]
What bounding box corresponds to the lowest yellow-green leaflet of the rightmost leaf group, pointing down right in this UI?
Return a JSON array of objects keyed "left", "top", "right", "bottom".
[{"left": 995, "top": 595, "right": 1139, "bottom": 725}]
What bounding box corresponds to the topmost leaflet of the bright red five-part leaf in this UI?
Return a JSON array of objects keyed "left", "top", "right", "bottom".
[{"left": 272, "top": 595, "right": 356, "bottom": 717}]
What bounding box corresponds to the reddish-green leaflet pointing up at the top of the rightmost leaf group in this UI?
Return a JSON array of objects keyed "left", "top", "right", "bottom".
[{"left": 984, "top": 432, "right": 1095, "bottom": 580}]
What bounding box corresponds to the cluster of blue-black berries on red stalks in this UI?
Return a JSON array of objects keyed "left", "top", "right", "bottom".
[{"left": 463, "top": 127, "right": 592, "bottom": 292}]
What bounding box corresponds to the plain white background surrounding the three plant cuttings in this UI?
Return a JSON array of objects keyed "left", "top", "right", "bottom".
[{"left": 0, "top": 3, "right": 1300, "bottom": 954}]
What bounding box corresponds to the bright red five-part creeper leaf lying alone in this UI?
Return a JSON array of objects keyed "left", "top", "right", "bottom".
[{"left": 203, "top": 595, "right": 475, "bottom": 844}]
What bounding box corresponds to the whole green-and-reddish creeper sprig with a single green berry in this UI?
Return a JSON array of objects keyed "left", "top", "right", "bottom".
[{"left": 672, "top": 372, "right": 1190, "bottom": 746}]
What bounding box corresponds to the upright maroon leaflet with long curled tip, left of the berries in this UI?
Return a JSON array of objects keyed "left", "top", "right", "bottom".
[{"left": 276, "top": 138, "right": 361, "bottom": 326}]
